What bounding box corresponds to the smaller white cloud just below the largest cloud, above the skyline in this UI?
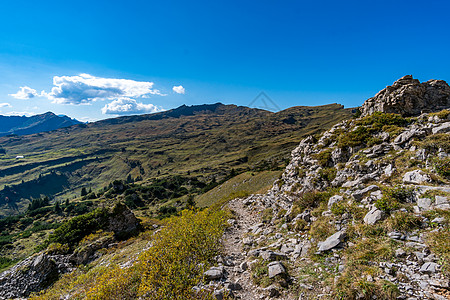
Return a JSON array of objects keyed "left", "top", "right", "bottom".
[{"left": 102, "top": 98, "right": 163, "bottom": 115}]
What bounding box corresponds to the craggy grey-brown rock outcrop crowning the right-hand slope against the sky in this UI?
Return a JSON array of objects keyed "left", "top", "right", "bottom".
[{"left": 361, "top": 75, "right": 450, "bottom": 116}]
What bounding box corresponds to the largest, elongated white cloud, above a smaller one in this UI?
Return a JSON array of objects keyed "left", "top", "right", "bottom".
[{"left": 45, "top": 74, "right": 164, "bottom": 105}]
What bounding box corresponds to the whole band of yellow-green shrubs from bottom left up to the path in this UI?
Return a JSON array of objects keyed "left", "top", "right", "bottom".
[{"left": 32, "top": 209, "right": 228, "bottom": 300}]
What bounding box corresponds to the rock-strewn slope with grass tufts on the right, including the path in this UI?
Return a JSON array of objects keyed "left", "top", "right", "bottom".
[{"left": 209, "top": 76, "right": 450, "bottom": 300}]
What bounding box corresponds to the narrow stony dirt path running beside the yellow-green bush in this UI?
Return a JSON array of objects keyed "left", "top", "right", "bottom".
[{"left": 223, "top": 198, "right": 265, "bottom": 300}]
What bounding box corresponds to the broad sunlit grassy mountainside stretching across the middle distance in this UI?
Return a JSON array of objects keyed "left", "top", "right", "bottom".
[{"left": 0, "top": 104, "right": 351, "bottom": 215}]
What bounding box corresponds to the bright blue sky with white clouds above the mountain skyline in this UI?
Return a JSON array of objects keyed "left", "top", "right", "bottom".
[{"left": 0, "top": 0, "right": 450, "bottom": 120}]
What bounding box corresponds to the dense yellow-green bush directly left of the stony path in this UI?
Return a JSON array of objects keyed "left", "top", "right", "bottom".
[{"left": 139, "top": 210, "right": 226, "bottom": 299}]
